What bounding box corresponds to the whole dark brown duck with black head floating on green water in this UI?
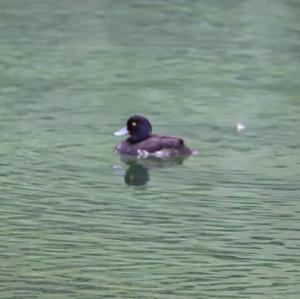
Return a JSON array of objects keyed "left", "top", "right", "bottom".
[{"left": 114, "top": 115, "right": 193, "bottom": 159}]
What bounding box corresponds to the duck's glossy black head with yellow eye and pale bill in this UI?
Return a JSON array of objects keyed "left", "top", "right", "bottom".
[{"left": 115, "top": 115, "right": 152, "bottom": 143}]
